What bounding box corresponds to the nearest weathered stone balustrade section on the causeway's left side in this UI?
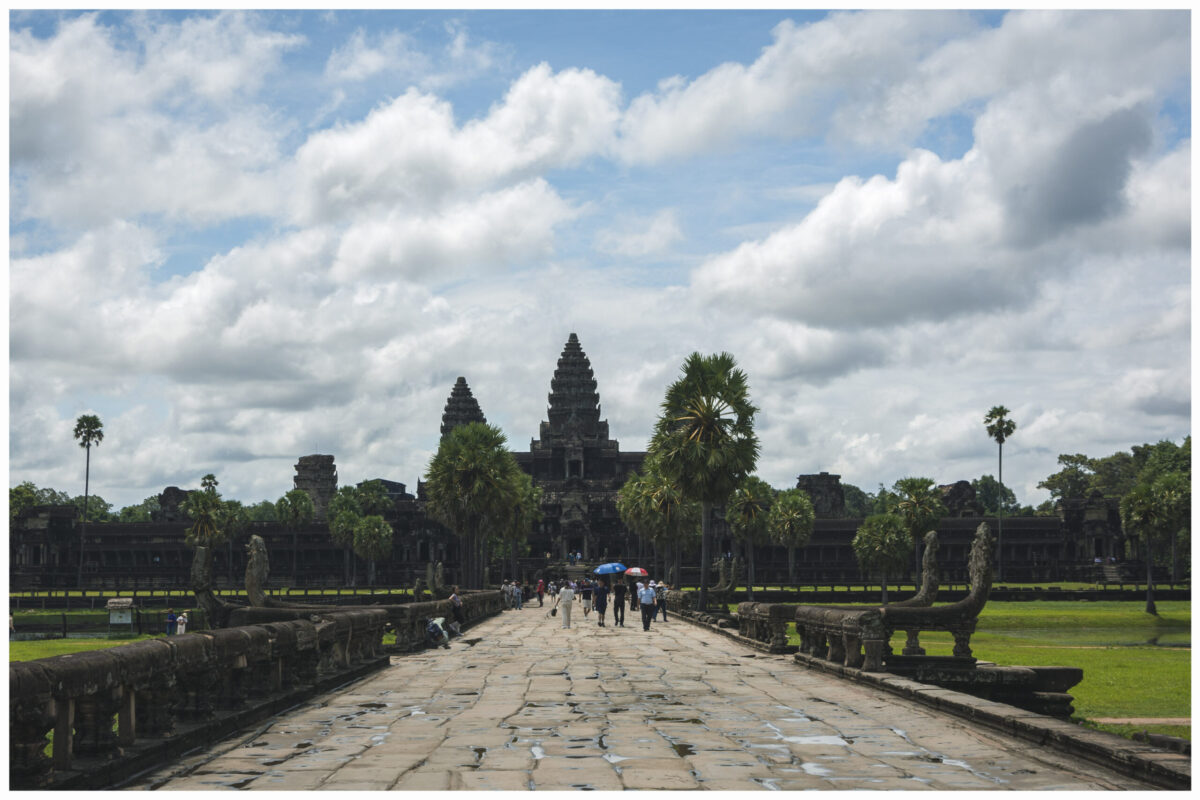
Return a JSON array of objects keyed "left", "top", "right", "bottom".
[{"left": 8, "top": 608, "right": 388, "bottom": 789}]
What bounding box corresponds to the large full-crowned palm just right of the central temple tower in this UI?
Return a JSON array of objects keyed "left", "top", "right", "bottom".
[{"left": 650, "top": 353, "right": 758, "bottom": 610}]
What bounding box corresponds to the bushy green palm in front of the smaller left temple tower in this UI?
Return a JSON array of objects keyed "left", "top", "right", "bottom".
[{"left": 425, "top": 422, "right": 521, "bottom": 589}]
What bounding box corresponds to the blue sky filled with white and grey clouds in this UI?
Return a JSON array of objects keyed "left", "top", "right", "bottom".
[{"left": 8, "top": 11, "right": 1192, "bottom": 506}]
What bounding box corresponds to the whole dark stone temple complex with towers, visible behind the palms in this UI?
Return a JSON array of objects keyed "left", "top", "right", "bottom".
[{"left": 10, "top": 333, "right": 1126, "bottom": 589}]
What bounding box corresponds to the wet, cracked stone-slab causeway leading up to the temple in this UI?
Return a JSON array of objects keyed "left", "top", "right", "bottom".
[{"left": 130, "top": 607, "right": 1148, "bottom": 792}]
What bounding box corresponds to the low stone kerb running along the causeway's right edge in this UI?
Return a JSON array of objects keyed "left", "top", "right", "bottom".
[{"left": 674, "top": 610, "right": 1192, "bottom": 789}]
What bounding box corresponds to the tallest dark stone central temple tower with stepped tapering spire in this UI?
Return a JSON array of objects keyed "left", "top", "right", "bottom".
[{"left": 514, "top": 333, "right": 646, "bottom": 559}]
